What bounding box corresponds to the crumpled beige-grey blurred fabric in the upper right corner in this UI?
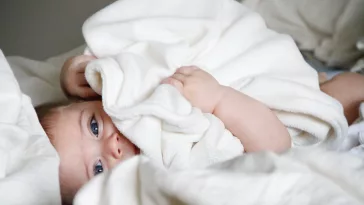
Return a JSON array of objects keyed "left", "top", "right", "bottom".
[{"left": 243, "top": 0, "right": 364, "bottom": 68}]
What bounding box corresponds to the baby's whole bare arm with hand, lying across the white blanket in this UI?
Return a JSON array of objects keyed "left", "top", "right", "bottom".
[{"left": 164, "top": 66, "right": 291, "bottom": 152}]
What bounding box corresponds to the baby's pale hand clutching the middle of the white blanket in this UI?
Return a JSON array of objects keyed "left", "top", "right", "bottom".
[{"left": 162, "top": 66, "right": 224, "bottom": 113}]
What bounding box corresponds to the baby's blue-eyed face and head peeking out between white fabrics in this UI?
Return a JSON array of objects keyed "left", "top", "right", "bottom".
[{"left": 37, "top": 101, "right": 139, "bottom": 202}]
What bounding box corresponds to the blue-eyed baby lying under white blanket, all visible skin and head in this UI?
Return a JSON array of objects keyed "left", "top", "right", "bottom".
[{"left": 37, "top": 55, "right": 364, "bottom": 202}]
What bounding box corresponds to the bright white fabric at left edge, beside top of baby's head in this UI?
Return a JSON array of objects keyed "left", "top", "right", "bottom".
[{"left": 0, "top": 50, "right": 61, "bottom": 205}]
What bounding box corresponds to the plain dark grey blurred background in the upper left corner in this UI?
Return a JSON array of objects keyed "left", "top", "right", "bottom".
[{"left": 0, "top": 0, "right": 113, "bottom": 60}]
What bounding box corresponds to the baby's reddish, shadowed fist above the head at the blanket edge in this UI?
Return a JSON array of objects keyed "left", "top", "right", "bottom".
[{"left": 61, "top": 55, "right": 98, "bottom": 99}]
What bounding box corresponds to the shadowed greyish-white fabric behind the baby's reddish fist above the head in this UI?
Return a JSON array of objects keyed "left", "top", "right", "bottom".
[{"left": 6, "top": 45, "right": 85, "bottom": 106}]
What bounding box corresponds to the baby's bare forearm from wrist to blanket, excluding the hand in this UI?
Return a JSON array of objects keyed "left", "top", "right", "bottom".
[{"left": 213, "top": 87, "right": 291, "bottom": 152}]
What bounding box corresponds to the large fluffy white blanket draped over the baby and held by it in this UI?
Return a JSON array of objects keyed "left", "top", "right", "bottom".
[{"left": 83, "top": 0, "right": 347, "bottom": 168}]
